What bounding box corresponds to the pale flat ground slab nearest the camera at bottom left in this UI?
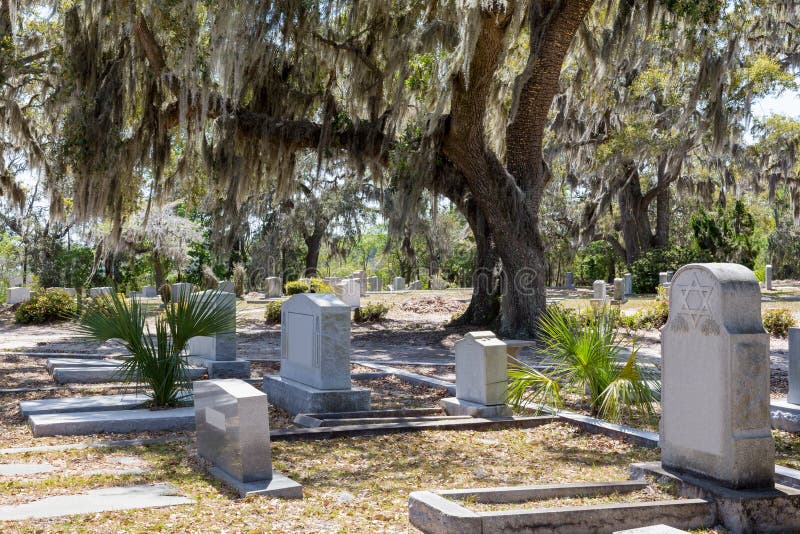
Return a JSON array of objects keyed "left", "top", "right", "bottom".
[{"left": 0, "top": 484, "right": 194, "bottom": 521}]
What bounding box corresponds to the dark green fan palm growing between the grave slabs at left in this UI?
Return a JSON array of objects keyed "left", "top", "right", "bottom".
[{"left": 79, "top": 291, "right": 236, "bottom": 408}]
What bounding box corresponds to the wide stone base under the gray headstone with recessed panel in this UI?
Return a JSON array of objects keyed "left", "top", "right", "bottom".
[{"left": 262, "top": 375, "right": 370, "bottom": 415}]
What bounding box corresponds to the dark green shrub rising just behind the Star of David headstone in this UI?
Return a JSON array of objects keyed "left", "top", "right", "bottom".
[{"left": 690, "top": 199, "right": 759, "bottom": 269}]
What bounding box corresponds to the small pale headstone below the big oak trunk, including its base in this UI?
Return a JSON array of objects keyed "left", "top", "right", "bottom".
[{"left": 441, "top": 332, "right": 511, "bottom": 417}]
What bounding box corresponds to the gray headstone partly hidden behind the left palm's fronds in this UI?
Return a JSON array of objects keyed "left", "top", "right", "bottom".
[{"left": 188, "top": 289, "right": 250, "bottom": 378}]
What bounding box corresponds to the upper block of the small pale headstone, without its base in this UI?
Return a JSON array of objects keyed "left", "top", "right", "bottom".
[{"left": 455, "top": 332, "right": 508, "bottom": 406}]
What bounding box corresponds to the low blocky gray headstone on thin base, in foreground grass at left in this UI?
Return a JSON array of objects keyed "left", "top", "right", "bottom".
[{"left": 193, "top": 379, "right": 303, "bottom": 498}]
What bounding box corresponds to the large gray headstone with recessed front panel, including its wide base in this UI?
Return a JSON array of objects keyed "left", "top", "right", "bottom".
[{"left": 263, "top": 294, "right": 370, "bottom": 413}]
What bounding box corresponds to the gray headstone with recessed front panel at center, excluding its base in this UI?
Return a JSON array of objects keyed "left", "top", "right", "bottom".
[{"left": 280, "top": 293, "right": 351, "bottom": 390}]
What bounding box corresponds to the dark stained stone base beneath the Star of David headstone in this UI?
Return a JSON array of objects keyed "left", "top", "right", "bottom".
[{"left": 630, "top": 462, "right": 800, "bottom": 532}]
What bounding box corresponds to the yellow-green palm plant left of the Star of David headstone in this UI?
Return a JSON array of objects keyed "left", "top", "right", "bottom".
[{"left": 508, "top": 307, "right": 660, "bottom": 421}]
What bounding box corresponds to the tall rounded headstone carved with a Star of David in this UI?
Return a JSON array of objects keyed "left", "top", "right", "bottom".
[{"left": 660, "top": 263, "right": 775, "bottom": 489}]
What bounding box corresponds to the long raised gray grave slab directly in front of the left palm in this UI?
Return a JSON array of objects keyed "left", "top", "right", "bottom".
[{"left": 28, "top": 407, "right": 194, "bottom": 437}]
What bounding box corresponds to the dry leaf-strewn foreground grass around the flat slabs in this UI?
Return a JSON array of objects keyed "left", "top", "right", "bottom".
[{"left": 0, "top": 423, "right": 800, "bottom": 532}]
